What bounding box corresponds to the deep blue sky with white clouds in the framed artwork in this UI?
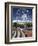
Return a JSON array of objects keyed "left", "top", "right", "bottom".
[{"left": 11, "top": 6, "right": 32, "bottom": 21}]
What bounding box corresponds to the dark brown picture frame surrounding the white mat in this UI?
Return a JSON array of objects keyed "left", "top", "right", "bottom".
[{"left": 5, "top": 2, "right": 37, "bottom": 44}]
